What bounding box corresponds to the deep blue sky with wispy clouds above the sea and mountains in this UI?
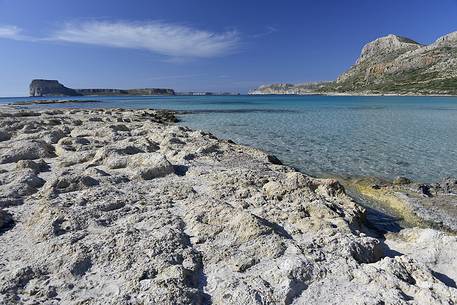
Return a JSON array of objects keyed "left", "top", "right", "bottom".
[{"left": 0, "top": 0, "right": 457, "bottom": 96}]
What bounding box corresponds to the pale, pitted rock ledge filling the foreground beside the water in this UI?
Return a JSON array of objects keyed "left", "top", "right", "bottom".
[{"left": 0, "top": 108, "right": 457, "bottom": 304}]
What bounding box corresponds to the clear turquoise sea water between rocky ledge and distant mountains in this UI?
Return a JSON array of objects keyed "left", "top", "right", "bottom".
[{"left": 0, "top": 96, "right": 457, "bottom": 182}]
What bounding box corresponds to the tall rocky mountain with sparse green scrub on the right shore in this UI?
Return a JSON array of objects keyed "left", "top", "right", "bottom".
[{"left": 249, "top": 32, "right": 457, "bottom": 95}]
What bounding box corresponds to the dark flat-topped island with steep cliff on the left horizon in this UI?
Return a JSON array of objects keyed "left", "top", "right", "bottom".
[{"left": 30, "top": 79, "right": 175, "bottom": 96}]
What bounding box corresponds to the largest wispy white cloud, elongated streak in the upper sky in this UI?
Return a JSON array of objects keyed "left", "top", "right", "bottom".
[{"left": 49, "top": 21, "right": 240, "bottom": 58}]
